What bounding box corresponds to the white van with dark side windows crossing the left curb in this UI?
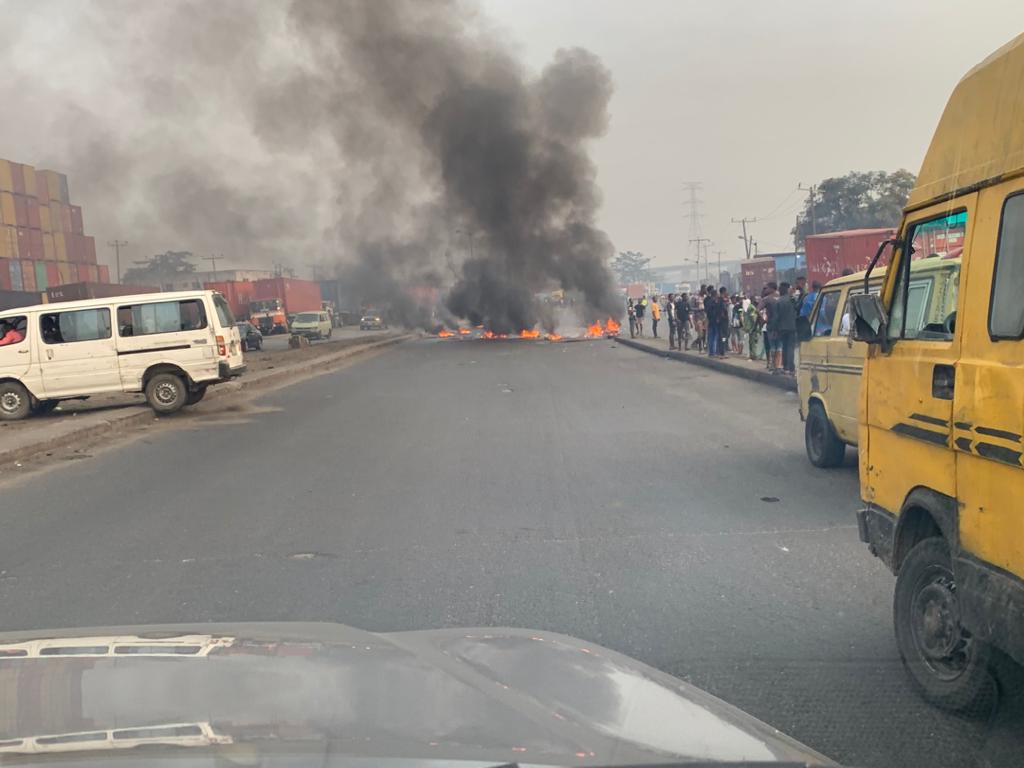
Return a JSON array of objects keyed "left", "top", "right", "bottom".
[{"left": 0, "top": 291, "right": 245, "bottom": 420}]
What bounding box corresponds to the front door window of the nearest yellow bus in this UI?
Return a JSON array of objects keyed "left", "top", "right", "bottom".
[{"left": 889, "top": 211, "right": 967, "bottom": 341}]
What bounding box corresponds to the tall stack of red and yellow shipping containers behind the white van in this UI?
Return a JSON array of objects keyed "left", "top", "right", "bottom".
[{"left": 0, "top": 160, "right": 110, "bottom": 293}]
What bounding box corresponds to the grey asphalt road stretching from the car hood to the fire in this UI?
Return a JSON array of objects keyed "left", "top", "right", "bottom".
[{"left": 0, "top": 340, "right": 1024, "bottom": 767}]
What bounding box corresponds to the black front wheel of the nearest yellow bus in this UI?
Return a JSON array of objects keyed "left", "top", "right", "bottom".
[{"left": 893, "top": 538, "right": 996, "bottom": 712}]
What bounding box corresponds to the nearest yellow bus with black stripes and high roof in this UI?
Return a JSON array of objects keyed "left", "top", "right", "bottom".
[{"left": 851, "top": 35, "right": 1024, "bottom": 710}]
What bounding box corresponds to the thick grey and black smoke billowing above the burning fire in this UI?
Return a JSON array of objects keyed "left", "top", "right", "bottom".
[{"left": 0, "top": 0, "right": 617, "bottom": 332}]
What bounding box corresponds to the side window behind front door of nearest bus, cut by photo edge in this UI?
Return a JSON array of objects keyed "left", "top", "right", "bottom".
[{"left": 988, "top": 194, "right": 1024, "bottom": 339}]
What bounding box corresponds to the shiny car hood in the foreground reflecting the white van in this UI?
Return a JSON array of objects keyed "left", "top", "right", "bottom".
[{"left": 0, "top": 624, "right": 831, "bottom": 765}]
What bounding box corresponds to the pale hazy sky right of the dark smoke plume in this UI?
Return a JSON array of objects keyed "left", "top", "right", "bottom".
[{"left": 483, "top": 0, "right": 1024, "bottom": 264}]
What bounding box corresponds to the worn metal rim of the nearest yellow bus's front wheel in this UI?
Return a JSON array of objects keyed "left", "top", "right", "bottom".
[{"left": 910, "top": 565, "right": 974, "bottom": 681}]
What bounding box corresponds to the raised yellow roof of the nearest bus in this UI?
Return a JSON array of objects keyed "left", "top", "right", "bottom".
[{"left": 900, "top": 35, "right": 1024, "bottom": 210}]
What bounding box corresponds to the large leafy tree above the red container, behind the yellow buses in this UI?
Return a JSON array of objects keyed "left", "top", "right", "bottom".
[{"left": 791, "top": 169, "right": 916, "bottom": 247}]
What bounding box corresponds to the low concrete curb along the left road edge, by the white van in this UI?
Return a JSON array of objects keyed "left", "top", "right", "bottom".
[{"left": 0, "top": 334, "right": 413, "bottom": 467}]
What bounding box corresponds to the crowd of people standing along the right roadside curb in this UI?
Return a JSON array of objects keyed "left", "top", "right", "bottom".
[{"left": 626, "top": 276, "right": 821, "bottom": 376}]
